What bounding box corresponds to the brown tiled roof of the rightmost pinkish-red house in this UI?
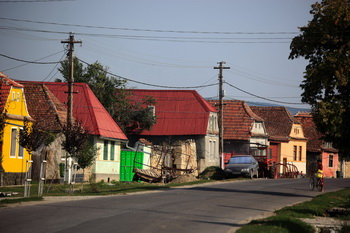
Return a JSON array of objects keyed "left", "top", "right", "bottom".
[{"left": 295, "top": 112, "right": 337, "bottom": 152}]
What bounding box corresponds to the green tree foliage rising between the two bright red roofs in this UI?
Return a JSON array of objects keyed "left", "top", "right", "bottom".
[{"left": 56, "top": 58, "right": 155, "bottom": 135}]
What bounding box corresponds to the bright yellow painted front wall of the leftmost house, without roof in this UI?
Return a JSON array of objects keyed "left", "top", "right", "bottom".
[{"left": 2, "top": 86, "right": 31, "bottom": 173}]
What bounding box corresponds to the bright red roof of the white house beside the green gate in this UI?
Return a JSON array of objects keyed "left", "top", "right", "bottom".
[{"left": 19, "top": 82, "right": 127, "bottom": 140}]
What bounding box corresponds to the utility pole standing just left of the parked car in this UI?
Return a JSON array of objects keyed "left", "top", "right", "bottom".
[{"left": 214, "top": 61, "right": 230, "bottom": 168}]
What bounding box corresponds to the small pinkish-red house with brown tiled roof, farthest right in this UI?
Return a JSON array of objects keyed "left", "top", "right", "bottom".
[{"left": 295, "top": 112, "right": 340, "bottom": 178}]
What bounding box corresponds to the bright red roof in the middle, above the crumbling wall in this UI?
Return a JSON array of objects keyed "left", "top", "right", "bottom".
[{"left": 130, "top": 89, "right": 216, "bottom": 136}]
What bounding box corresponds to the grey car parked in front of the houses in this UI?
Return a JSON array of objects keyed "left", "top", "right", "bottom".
[{"left": 224, "top": 155, "right": 259, "bottom": 178}]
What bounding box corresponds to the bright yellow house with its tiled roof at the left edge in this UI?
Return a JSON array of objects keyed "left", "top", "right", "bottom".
[{"left": 0, "top": 72, "right": 32, "bottom": 180}]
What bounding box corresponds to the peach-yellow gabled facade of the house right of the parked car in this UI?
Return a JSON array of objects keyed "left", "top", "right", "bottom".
[{"left": 279, "top": 124, "right": 307, "bottom": 174}]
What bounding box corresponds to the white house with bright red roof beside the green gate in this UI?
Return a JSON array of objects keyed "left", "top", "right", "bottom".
[{"left": 21, "top": 82, "right": 127, "bottom": 181}]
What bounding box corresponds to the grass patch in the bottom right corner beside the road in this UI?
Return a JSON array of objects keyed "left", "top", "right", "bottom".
[{"left": 237, "top": 189, "right": 350, "bottom": 233}]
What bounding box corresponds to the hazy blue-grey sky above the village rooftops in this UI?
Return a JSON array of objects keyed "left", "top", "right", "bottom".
[{"left": 0, "top": 0, "right": 316, "bottom": 109}]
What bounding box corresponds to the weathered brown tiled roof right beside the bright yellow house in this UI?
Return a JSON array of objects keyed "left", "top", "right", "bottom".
[{"left": 19, "top": 81, "right": 67, "bottom": 131}]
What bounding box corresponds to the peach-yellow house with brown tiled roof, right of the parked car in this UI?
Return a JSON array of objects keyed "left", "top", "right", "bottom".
[{"left": 250, "top": 106, "right": 307, "bottom": 175}]
